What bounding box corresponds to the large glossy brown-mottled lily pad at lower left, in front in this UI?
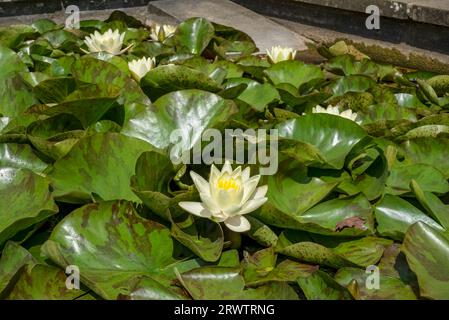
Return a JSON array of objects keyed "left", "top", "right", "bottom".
[{"left": 43, "top": 201, "right": 194, "bottom": 299}]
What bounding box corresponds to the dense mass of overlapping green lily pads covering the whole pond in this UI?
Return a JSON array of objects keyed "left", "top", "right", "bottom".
[{"left": 0, "top": 11, "right": 449, "bottom": 300}]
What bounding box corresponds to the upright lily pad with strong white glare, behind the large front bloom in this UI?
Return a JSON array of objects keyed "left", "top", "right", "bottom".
[{"left": 122, "top": 90, "right": 235, "bottom": 158}]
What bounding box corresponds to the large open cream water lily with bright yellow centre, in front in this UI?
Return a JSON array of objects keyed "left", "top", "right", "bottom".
[{"left": 179, "top": 161, "right": 268, "bottom": 232}]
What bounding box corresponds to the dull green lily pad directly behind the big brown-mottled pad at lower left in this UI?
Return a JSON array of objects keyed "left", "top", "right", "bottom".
[{"left": 49, "top": 133, "right": 152, "bottom": 203}]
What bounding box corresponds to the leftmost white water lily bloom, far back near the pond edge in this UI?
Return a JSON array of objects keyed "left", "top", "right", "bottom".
[{"left": 84, "top": 29, "right": 131, "bottom": 55}]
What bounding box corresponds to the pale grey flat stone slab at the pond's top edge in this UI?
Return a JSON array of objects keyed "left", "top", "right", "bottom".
[{"left": 149, "top": 0, "right": 308, "bottom": 52}]
